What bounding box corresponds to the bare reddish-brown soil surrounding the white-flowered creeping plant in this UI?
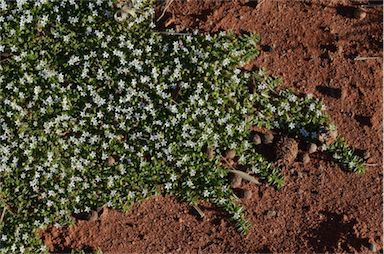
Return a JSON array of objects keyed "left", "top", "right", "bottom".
[{"left": 42, "top": 0, "right": 383, "bottom": 253}]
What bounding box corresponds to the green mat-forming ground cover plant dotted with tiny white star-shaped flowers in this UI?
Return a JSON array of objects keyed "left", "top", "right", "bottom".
[{"left": 0, "top": 1, "right": 364, "bottom": 253}]
